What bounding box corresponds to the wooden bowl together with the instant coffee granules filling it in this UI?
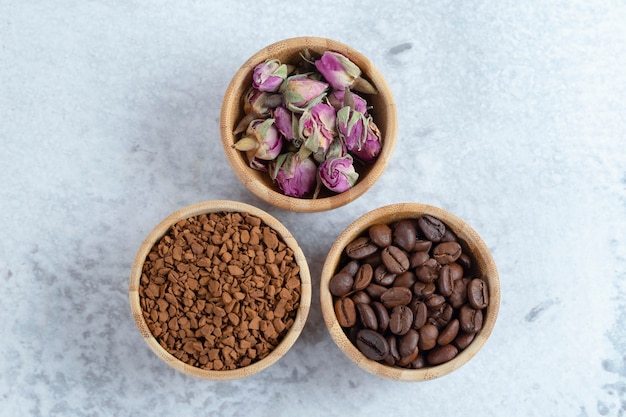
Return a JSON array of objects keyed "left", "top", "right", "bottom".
[{"left": 130, "top": 201, "right": 311, "bottom": 380}]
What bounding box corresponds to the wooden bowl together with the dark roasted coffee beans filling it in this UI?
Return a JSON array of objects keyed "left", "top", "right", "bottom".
[{"left": 320, "top": 203, "right": 500, "bottom": 381}]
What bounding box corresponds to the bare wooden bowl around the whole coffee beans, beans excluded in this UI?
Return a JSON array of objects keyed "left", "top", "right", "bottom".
[{"left": 320, "top": 203, "right": 500, "bottom": 381}]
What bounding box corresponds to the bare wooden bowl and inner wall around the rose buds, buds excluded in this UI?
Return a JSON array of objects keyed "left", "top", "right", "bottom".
[{"left": 220, "top": 37, "right": 398, "bottom": 212}]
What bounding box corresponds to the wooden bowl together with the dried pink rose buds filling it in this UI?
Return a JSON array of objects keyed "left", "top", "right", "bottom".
[{"left": 220, "top": 37, "right": 397, "bottom": 212}]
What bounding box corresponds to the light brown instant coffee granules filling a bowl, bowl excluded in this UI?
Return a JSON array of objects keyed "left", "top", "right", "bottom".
[{"left": 139, "top": 212, "right": 301, "bottom": 370}]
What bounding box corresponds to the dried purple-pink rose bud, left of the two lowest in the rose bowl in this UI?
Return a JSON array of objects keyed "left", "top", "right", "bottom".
[{"left": 270, "top": 152, "right": 317, "bottom": 197}]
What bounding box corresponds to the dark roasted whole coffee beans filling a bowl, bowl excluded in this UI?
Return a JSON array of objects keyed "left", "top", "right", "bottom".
[{"left": 328, "top": 215, "right": 489, "bottom": 369}]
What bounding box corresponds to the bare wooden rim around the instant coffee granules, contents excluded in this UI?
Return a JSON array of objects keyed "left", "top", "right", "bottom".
[{"left": 130, "top": 200, "right": 311, "bottom": 381}]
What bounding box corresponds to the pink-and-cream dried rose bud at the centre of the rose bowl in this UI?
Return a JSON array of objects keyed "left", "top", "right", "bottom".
[{"left": 298, "top": 103, "right": 336, "bottom": 154}]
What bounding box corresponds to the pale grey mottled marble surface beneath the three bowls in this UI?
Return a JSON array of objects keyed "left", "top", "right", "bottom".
[{"left": 0, "top": 0, "right": 626, "bottom": 417}]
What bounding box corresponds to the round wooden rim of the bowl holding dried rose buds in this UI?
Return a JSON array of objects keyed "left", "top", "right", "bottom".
[{"left": 220, "top": 36, "right": 398, "bottom": 212}]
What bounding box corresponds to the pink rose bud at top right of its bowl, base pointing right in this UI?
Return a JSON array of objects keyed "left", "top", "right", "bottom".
[{"left": 315, "top": 51, "right": 376, "bottom": 94}]
